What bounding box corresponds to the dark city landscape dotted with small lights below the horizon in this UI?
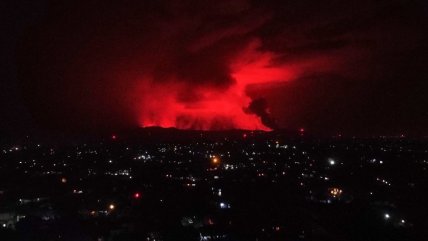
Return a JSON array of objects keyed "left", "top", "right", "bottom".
[{"left": 0, "top": 132, "right": 428, "bottom": 241}]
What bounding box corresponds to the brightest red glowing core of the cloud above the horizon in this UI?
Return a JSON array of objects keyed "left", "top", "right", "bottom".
[{"left": 135, "top": 40, "right": 295, "bottom": 130}]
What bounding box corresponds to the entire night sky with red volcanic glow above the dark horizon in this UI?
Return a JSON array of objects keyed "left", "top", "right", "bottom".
[{"left": 0, "top": 0, "right": 428, "bottom": 135}]
